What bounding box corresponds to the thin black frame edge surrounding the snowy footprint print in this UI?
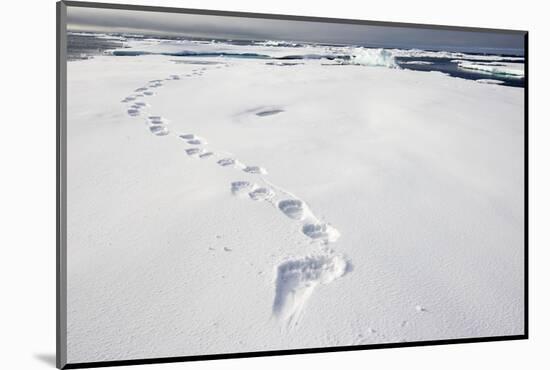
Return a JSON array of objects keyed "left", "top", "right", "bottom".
[{"left": 56, "top": 1, "right": 529, "bottom": 369}]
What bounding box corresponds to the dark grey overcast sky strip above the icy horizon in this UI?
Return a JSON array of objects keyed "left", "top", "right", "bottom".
[{"left": 67, "top": 7, "right": 523, "bottom": 52}]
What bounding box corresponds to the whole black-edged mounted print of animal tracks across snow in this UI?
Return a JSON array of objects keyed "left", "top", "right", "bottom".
[{"left": 57, "top": 1, "right": 527, "bottom": 368}]
